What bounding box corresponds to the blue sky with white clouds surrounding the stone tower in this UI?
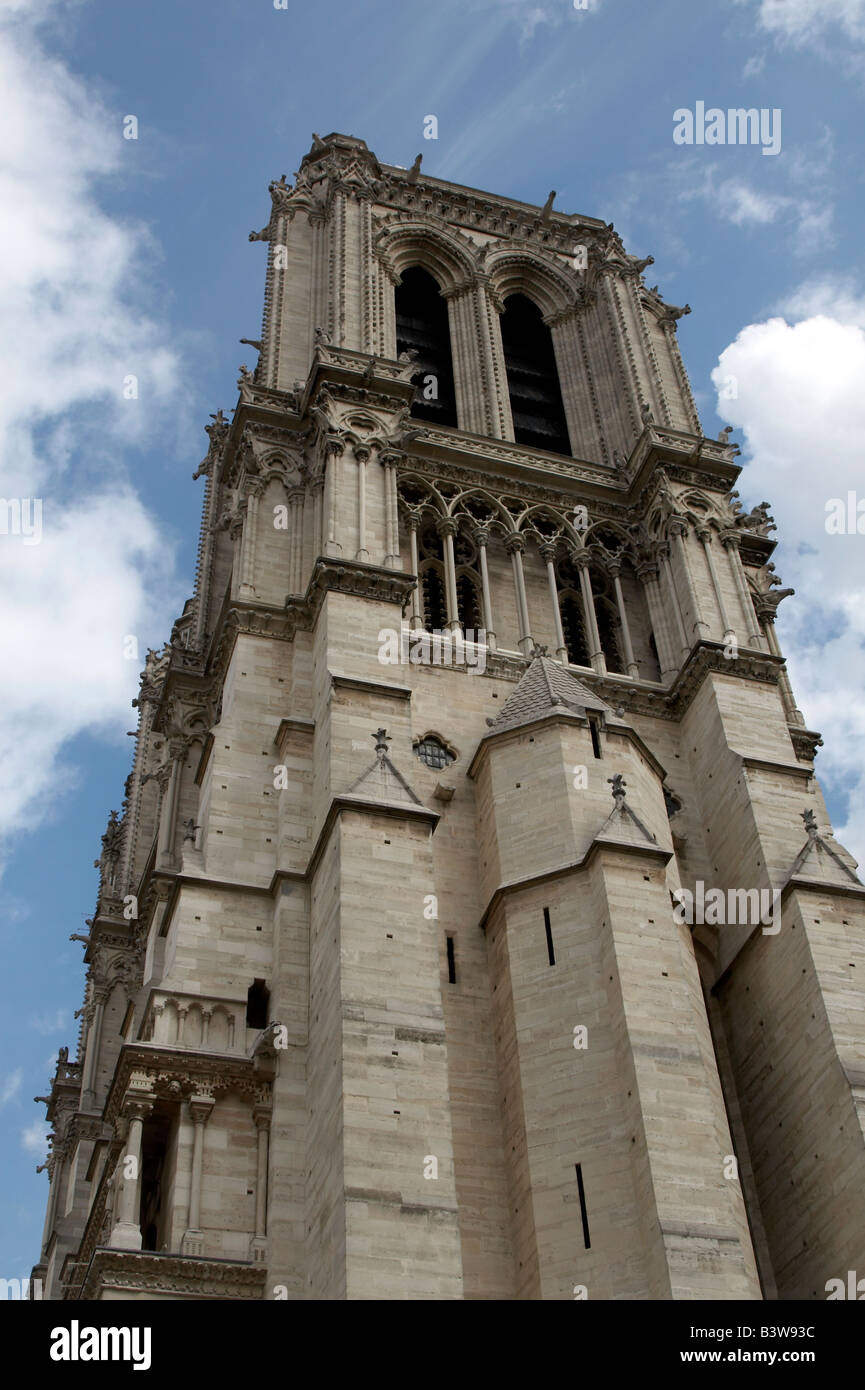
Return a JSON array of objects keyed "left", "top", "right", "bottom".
[{"left": 0, "top": 0, "right": 865, "bottom": 1277}]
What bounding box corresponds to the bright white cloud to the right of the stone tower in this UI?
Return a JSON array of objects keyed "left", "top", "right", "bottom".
[{"left": 712, "top": 279, "right": 865, "bottom": 862}]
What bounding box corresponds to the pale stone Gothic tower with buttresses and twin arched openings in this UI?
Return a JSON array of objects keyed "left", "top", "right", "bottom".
[{"left": 35, "top": 135, "right": 865, "bottom": 1300}]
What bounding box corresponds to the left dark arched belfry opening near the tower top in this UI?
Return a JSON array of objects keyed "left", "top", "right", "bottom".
[{"left": 395, "top": 265, "right": 456, "bottom": 425}]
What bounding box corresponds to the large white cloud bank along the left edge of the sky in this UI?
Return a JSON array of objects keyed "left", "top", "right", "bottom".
[{"left": 0, "top": 0, "right": 187, "bottom": 856}]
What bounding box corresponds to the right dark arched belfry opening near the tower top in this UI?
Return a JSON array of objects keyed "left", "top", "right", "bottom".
[{"left": 502, "top": 295, "right": 570, "bottom": 453}]
